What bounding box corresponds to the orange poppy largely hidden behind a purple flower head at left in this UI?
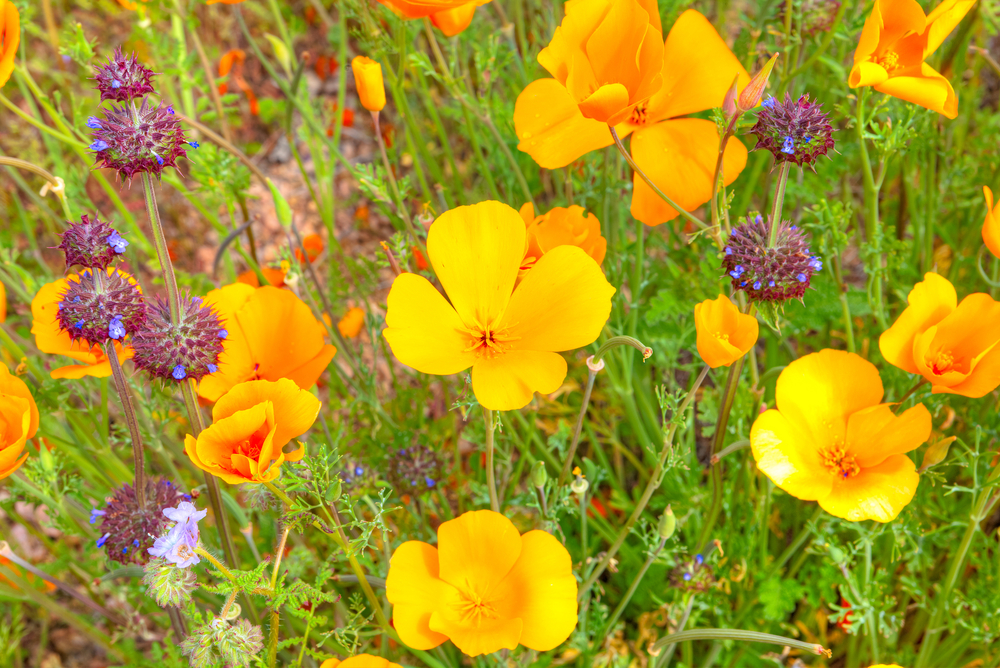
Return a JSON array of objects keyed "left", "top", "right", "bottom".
[{"left": 31, "top": 268, "right": 135, "bottom": 378}]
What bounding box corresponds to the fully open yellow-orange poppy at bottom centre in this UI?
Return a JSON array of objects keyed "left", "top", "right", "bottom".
[{"left": 385, "top": 510, "right": 577, "bottom": 656}]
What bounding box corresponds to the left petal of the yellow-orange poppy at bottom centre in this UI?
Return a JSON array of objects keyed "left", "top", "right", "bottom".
[{"left": 385, "top": 540, "right": 454, "bottom": 650}]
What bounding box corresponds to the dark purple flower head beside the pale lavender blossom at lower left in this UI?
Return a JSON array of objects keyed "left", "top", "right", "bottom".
[{"left": 91, "top": 478, "right": 188, "bottom": 564}]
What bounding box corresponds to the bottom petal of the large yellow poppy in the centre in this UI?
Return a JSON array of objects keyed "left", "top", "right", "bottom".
[{"left": 472, "top": 350, "right": 566, "bottom": 411}]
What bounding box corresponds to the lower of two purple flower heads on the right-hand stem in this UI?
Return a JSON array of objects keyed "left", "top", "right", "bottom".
[{"left": 722, "top": 215, "right": 823, "bottom": 302}]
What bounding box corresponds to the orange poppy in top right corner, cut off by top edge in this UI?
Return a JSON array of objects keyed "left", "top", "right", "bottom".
[{"left": 848, "top": 0, "right": 976, "bottom": 118}]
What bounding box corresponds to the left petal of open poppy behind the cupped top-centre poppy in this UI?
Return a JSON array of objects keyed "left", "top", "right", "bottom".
[{"left": 514, "top": 79, "right": 616, "bottom": 169}]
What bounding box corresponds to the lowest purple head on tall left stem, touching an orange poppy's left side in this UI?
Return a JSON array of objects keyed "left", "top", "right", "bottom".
[{"left": 132, "top": 295, "right": 222, "bottom": 382}]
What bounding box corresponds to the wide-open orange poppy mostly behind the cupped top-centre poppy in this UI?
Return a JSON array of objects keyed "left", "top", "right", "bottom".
[{"left": 514, "top": 9, "right": 750, "bottom": 225}]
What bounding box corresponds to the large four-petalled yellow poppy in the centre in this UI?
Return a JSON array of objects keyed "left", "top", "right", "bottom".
[{"left": 382, "top": 202, "right": 615, "bottom": 410}]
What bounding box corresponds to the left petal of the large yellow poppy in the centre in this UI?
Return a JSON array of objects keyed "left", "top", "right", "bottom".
[{"left": 382, "top": 273, "right": 476, "bottom": 375}]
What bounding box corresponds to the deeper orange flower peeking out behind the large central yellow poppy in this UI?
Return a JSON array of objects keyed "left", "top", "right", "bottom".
[{"left": 519, "top": 202, "right": 608, "bottom": 271}]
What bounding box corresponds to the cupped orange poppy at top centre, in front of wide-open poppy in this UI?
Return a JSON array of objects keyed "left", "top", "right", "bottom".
[{"left": 538, "top": 0, "right": 663, "bottom": 125}]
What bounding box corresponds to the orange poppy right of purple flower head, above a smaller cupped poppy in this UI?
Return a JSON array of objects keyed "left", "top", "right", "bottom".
[{"left": 198, "top": 283, "right": 337, "bottom": 401}]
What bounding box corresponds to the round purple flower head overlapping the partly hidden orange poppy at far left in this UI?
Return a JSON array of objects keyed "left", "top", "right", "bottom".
[{"left": 57, "top": 269, "right": 146, "bottom": 346}]
